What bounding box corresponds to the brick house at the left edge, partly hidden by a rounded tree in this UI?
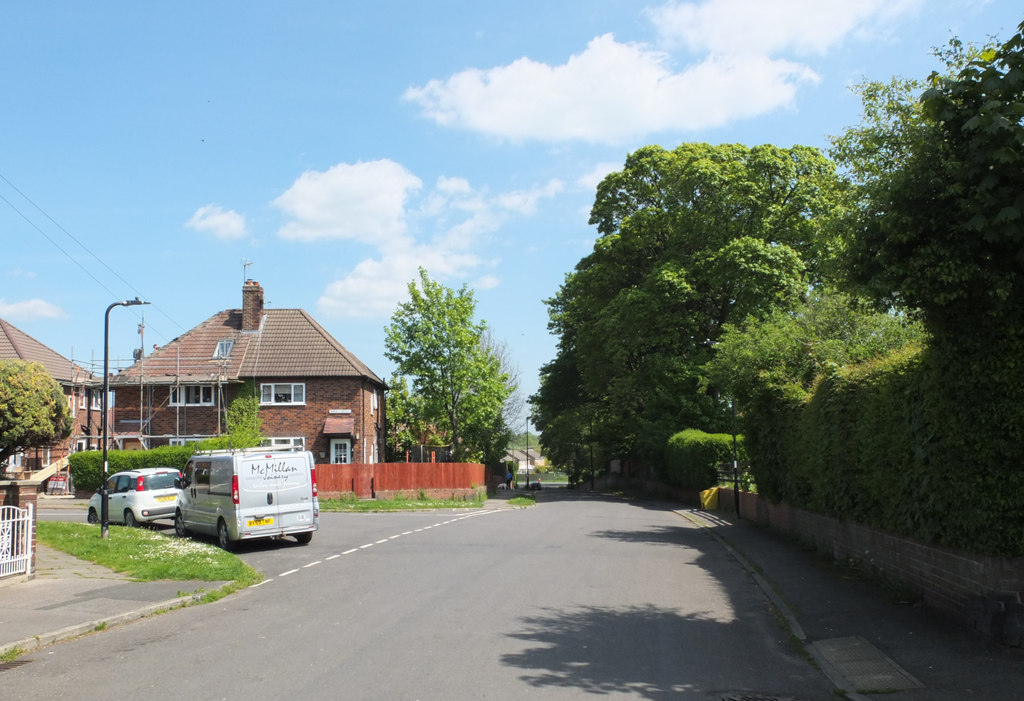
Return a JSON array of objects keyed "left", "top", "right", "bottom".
[{"left": 0, "top": 319, "right": 103, "bottom": 474}]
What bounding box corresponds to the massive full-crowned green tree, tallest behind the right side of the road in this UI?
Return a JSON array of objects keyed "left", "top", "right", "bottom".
[{"left": 534, "top": 143, "right": 845, "bottom": 464}]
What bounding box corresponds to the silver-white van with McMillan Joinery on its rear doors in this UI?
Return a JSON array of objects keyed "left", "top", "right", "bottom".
[{"left": 174, "top": 448, "right": 319, "bottom": 550}]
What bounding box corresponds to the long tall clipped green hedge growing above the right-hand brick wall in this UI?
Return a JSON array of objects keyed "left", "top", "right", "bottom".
[{"left": 744, "top": 341, "right": 1024, "bottom": 557}]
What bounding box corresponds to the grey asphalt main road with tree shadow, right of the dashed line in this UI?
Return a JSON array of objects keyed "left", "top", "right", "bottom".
[{"left": 16, "top": 490, "right": 834, "bottom": 701}]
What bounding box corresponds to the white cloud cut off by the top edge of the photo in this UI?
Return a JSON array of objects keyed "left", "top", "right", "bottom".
[{"left": 647, "top": 0, "right": 923, "bottom": 55}]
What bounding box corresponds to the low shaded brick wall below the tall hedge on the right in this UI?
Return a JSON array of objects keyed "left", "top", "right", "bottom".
[{"left": 720, "top": 489, "right": 1024, "bottom": 647}]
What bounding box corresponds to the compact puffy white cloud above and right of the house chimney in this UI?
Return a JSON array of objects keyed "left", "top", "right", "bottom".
[{"left": 273, "top": 159, "right": 423, "bottom": 245}]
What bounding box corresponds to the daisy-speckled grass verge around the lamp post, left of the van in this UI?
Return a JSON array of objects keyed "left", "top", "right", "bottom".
[{"left": 37, "top": 521, "right": 263, "bottom": 589}]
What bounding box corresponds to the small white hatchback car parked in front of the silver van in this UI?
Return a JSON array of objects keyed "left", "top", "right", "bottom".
[{"left": 88, "top": 468, "right": 181, "bottom": 527}]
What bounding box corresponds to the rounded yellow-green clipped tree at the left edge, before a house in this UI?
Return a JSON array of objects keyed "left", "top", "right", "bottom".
[{"left": 0, "top": 360, "right": 72, "bottom": 464}]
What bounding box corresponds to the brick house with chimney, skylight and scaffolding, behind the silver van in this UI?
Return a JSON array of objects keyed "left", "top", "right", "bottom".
[{"left": 110, "top": 280, "right": 385, "bottom": 463}]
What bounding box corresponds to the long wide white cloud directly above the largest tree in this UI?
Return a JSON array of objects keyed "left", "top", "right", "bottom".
[{"left": 404, "top": 34, "right": 817, "bottom": 143}]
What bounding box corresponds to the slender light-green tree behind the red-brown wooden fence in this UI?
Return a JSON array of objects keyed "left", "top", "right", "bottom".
[{"left": 385, "top": 268, "right": 514, "bottom": 462}]
